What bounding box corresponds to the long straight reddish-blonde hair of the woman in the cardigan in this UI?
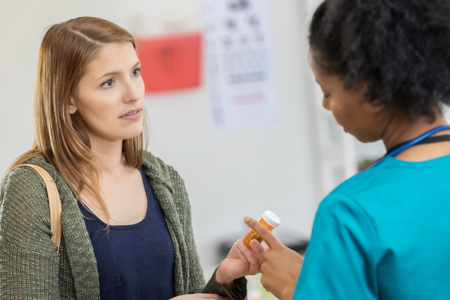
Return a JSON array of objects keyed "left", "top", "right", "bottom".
[{"left": 9, "top": 17, "right": 147, "bottom": 224}]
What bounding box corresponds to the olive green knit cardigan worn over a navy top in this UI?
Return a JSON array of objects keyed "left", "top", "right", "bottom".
[{"left": 0, "top": 153, "right": 247, "bottom": 300}]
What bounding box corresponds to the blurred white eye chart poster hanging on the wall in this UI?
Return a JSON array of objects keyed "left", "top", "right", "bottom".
[{"left": 203, "top": 0, "right": 279, "bottom": 130}]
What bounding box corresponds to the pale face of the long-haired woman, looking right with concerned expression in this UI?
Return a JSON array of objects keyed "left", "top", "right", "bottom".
[{"left": 69, "top": 42, "right": 145, "bottom": 142}]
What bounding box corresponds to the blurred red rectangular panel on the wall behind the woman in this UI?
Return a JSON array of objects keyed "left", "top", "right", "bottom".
[{"left": 137, "top": 33, "right": 201, "bottom": 93}]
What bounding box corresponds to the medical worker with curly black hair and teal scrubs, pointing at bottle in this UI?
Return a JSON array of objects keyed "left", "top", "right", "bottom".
[{"left": 245, "top": 0, "right": 450, "bottom": 300}]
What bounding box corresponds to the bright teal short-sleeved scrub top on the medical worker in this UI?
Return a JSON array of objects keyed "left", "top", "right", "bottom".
[{"left": 293, "top": 155, "right": 450, "bottom": 300}]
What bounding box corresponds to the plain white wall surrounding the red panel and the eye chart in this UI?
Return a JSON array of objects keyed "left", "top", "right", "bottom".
[{"left": 0, "top": 0, "right": 320, "bottom": 276}]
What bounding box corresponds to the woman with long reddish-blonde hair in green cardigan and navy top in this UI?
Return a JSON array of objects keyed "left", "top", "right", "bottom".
[{"left": 0, "top": 17, "right": 259, "bottom": 300}]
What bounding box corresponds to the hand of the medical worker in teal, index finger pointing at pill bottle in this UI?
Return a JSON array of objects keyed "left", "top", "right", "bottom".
[{"left": 244, "top": 217, "right": 303, "bottom": 300}]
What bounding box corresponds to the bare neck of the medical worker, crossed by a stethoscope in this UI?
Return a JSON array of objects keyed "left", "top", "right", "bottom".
[{"left": 382, "top": 112, "right": 450, "bottom": 161}]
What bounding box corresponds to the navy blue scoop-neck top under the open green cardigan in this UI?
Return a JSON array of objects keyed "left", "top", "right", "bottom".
[{"left": 79, "top": 168, "right": 175, "bottom": 300}]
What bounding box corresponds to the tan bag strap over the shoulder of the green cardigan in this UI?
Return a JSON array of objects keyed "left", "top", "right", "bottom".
[{"left": 11, "top": 164, "right": 62, "bottom": 253}]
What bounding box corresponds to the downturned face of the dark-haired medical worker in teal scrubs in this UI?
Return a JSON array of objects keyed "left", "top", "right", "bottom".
[{"left": 308, "top": 50, "right": 386, "bottom": 142}]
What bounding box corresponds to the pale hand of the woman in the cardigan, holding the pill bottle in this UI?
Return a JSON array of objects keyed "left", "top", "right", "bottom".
[{"left": 216, "top": 240, "right": 264, "bottom": 286}]
